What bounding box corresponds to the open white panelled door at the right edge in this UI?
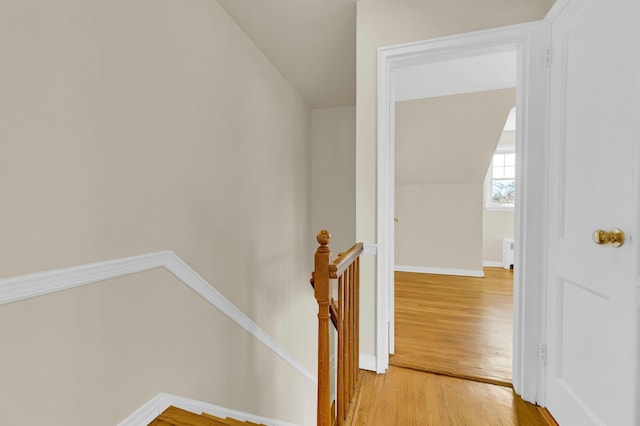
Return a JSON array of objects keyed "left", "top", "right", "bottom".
[{"left": 545, "top": 0, "right": 640, "bottom": 426}]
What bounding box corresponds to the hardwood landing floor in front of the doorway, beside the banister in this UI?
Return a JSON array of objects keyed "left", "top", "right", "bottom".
[{"left": 352, "top": 366, "right": 553, "bottom": 426}]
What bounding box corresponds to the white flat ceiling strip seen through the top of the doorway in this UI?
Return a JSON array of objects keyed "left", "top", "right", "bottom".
[{"left": 394, "top": 50, "right": 517, "bottom": 101}]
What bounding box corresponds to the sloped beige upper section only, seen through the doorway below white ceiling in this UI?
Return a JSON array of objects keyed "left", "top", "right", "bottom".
[{"left": 395, "top": 88, "right": 516, "bottom": 185}]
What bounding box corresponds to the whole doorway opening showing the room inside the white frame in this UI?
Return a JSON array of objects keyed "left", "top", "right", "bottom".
[{"left": 390, "top": 78, "right": 516, "bottom": 386}]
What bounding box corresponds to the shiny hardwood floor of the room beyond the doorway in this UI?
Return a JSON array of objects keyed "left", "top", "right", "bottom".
[{"left": 390, "top": 268, "right": 513, "bottom": 386}]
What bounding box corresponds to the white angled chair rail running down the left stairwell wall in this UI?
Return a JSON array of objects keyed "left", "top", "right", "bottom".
[{"left": 0, "top": 251, "right": 317, "bottom": 383}]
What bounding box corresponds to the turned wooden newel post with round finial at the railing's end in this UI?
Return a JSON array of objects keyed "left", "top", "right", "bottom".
[{"left": 313, "top": 230, "right": 331, "bottom": 426}]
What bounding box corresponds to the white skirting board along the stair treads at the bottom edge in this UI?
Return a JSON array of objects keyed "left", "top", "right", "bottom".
[{"left": 118, "top": 393, "right": 295, "bottom": 426}]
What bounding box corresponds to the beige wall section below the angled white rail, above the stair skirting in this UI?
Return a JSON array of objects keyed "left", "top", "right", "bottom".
[{"left": 0, "top": 268, "right": 315, "bottom": 426}]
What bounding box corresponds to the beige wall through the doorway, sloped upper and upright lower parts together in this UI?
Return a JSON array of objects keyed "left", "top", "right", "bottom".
[{"left": 395, "top": 88, "right": 515, "bottom": 272}]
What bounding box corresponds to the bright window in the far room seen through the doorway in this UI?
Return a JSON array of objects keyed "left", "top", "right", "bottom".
[{"left": 485, "top": 147, "right": 516, "bottom": 210}]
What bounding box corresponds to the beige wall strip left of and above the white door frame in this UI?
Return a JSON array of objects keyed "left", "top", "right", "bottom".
[{"left": 356, "top": 0, "right": 553, "bottom": 360}]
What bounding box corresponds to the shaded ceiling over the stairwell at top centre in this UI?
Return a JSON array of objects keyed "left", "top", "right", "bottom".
[{"left": 218, "top": 0, "right": 356, "bottom": 108}]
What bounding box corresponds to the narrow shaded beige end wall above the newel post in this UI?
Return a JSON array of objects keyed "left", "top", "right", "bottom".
[{"left": 310, "top": 106, "right": 356, "bottom": 254}]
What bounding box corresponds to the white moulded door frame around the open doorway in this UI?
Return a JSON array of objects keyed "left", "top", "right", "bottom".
[{"left": 376, "top": 21, "right": 549, "bottom": 404}]
